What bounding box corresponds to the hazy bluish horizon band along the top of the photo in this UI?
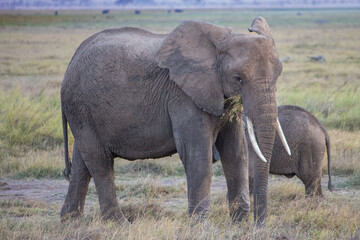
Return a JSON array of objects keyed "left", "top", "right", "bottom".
[{"left": 0, "top": 0, "right": 360, "bottom": 10}]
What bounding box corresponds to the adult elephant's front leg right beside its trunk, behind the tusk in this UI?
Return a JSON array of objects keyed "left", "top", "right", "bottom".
[{"left": 216, "top": 120, "right": 250, "bottom": 222}]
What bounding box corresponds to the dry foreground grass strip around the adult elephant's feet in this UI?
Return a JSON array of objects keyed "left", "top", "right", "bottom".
[{"left": 0, "top": 182, "right": 360, "bottom": 239}]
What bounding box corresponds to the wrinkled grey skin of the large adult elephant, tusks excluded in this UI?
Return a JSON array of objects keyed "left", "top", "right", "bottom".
[{"left": 61, "top": 17, "right": 282, "bottom": 225}]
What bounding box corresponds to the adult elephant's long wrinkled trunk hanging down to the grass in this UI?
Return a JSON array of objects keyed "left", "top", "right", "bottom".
[{"left": 244, "top": 88, "right": 277, "bottom": 226}]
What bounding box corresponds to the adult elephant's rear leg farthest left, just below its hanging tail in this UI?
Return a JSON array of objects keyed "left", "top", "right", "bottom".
[{"left": 60, "top": 142, "right": 91, "bottom": 219}]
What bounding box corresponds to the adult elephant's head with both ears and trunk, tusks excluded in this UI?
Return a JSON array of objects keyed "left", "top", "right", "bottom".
[{"left": 156, "top": 17, "right": 288, "bottom": 226}]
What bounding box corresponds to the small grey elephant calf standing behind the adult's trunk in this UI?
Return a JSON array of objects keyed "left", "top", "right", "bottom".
[{"left": 249, "top": 105, "right": 333, "bottom": 196}]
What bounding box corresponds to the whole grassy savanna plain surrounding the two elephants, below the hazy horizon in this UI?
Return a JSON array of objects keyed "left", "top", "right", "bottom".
[{"left": 0, "top": 9, "right": 360, "bottom": 239}]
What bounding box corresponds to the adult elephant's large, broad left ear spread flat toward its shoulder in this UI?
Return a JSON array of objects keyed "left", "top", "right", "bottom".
[{"left": 156, "top": 21, "right": 232, "bottom": 116}]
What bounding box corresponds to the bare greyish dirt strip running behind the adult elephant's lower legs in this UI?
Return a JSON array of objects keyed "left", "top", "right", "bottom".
[{"left": 0, "top": 176, "right": 360, "bottom": 210}]
